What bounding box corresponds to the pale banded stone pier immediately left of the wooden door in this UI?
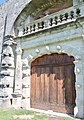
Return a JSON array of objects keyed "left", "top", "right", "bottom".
[{"left": 22, "top": 58, "right": 30, "bottom": 109}]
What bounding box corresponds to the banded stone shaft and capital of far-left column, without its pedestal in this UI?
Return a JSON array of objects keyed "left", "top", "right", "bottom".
[{"left": 0, "top": 35, "right": 15, "bottom": 98}]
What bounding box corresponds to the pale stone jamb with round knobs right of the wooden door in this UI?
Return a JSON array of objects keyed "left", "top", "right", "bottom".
[{"left": 74, "top": 60, "right": 84, "bottom": 118}]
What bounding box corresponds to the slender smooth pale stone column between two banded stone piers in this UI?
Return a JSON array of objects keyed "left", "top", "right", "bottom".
[{"left": 12, "top": 46, "right": 22, "bottom": 108}]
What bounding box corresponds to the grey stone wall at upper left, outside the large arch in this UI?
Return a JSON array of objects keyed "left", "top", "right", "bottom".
[{"left": 0, "top": 0, "right": 31, "bottom": 71}]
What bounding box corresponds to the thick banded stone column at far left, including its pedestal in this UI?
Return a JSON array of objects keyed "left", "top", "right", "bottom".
[{"left": 0, "top": 35, "right": 16, "bottom": 108}]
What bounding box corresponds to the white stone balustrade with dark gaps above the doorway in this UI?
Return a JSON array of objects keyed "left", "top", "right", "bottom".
[{"left": 19, "top": 8, "right": 81, "bottom": 36}]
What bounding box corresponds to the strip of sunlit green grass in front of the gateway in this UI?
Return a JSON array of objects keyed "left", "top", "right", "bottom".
[{"left": 0, "top": 109, "right": 84, "bottom": 120}]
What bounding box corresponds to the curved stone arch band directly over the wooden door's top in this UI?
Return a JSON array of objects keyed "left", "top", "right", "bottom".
[{"left": 28, "top": 44, "right": 83, "bottom": 66}]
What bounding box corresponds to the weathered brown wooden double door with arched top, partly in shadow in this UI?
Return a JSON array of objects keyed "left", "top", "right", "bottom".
[{"left": 30, "top": 54, "right": 76, "bottom": 114}]
